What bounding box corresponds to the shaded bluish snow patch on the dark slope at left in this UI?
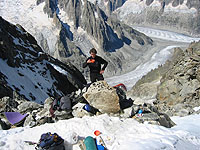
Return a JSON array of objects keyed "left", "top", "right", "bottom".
[{"left": 0, "top": 59, "right": 60, "bottom": 103}]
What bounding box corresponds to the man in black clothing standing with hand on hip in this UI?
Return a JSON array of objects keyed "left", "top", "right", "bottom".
[{"left": 83, "top": 48, "right": 108, "bottom": 83}]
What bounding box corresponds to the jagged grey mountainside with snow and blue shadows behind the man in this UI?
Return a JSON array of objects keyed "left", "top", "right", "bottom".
[{"left": 0, "top": 0, "right": 153, "bottom": 76}]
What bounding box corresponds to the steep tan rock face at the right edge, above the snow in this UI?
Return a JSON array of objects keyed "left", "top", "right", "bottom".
[{"left": 156, "top": 42, "right": 200, "bottom": 116}]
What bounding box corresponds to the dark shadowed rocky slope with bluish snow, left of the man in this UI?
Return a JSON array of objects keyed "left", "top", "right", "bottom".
[{"left": 0, "top": 17, "right": 86, "bottom": 103}]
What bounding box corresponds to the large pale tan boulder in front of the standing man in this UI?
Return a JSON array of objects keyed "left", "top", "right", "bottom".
[{"left": 83, "top": 81, "right": 120, "bottom": 113}]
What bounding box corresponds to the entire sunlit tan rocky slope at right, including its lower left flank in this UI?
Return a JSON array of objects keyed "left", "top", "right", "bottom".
[{"left": 128, "top": 42, "right": 200, "bottom": 116}]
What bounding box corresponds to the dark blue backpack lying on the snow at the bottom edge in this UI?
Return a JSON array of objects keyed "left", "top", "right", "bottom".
[{"left": 35, "top": 132, "right": 65, "bottom": 150}]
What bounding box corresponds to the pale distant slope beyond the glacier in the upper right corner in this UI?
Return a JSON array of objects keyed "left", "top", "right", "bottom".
[{"left": 114, "top": 0, "right": 200, "bottom": 36}]
